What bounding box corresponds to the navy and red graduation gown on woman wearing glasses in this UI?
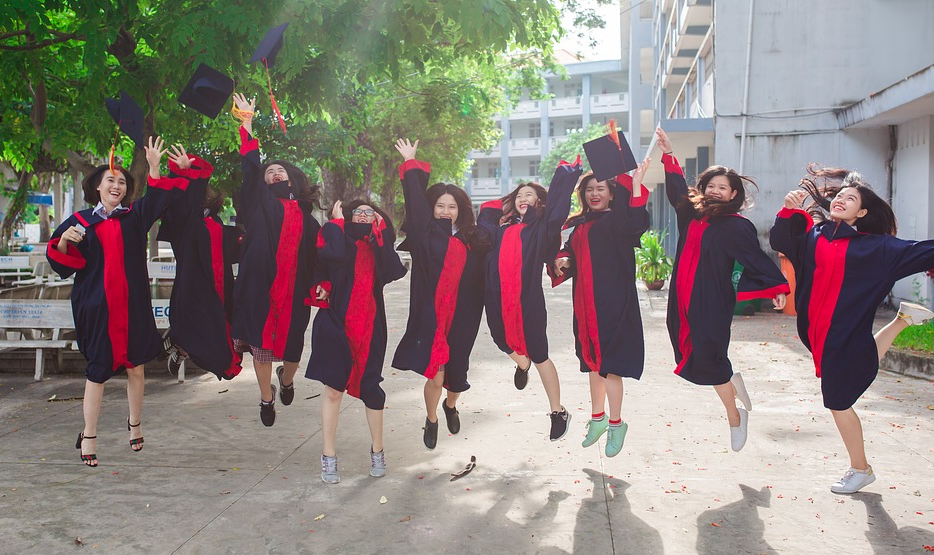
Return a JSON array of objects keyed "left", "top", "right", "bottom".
[{"left": 305, "top": 219, "right": 406, "bottom": 410}]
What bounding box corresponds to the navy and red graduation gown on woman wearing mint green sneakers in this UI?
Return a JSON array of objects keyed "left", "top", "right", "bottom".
[{"left": 548, "top": 175, "right": 649, "bottom": 379}]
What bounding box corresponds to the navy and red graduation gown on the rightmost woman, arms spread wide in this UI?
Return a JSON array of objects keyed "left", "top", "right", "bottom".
[{"left": 769, "top": 208, "right": 934, "bottom": 410}]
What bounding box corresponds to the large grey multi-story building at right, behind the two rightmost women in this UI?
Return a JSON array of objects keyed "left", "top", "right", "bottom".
[{"left": 620, "top": 0, "right": 934, "bottom": 299}]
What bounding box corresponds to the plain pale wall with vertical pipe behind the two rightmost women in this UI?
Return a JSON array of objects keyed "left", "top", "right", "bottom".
[{"left": 713, "top": 0, "right": 934, "bottom": 235}]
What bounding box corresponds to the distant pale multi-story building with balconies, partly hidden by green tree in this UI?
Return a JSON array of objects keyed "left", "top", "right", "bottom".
[{"left": 467, "top": 54, "right": 629, "bottom": 207}]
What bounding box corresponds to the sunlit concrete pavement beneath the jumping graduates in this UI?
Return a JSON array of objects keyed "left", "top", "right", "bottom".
[{"left": 0, "top": 281, "right": 934, "bottom": 554}]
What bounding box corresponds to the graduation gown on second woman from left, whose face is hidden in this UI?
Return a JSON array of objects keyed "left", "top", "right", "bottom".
[{"left": 159, "top": 155, "right": 241, "bottom": 380}]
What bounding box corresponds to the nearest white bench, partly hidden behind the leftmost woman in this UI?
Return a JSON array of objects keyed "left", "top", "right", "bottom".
[{"left": 0, "top": 300, "right": 185, "bottom": 382}]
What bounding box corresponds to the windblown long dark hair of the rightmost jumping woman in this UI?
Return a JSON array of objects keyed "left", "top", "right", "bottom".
[{"left": 801, "top": 162, "right": 898, "bottom": 235}]
